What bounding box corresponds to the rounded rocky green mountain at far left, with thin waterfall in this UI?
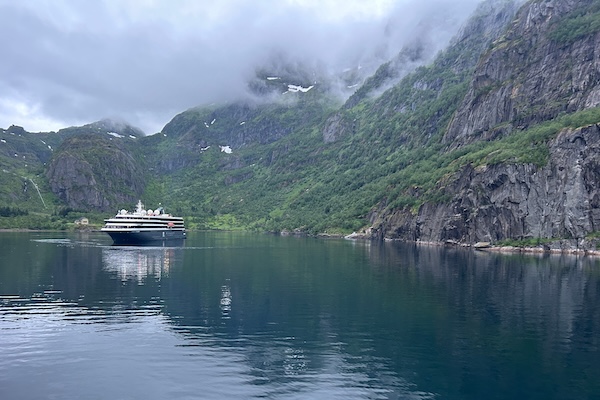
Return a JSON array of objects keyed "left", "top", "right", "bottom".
[{"left": 0, "top": 120, "right": 145, "bottom": 216}]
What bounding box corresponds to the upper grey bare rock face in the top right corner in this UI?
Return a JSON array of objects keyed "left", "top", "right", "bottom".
[{"left": 444, "top": 0, "right": 600, "bottom": 148}]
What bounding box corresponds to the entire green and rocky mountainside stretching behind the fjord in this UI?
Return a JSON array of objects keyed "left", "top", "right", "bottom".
[{"left": 0, "top": 0, "right": 600, "bottom": 247}]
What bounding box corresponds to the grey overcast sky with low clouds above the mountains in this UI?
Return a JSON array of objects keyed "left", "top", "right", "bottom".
[{"left": 0, "top": 0, "right": 480, "bottom": 134}]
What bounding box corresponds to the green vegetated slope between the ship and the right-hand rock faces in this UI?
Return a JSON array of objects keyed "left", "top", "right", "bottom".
[{"left": 137, "top": 32, "right": 492, "bottom": 233}]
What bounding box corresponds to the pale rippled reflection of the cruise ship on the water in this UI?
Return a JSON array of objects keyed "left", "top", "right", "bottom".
[{"left": 102, "top": 245, "right": 181, "bottom": 285}]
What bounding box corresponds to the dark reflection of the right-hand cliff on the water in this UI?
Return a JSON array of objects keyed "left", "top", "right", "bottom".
[{"left": 368, "top": 243, "right": 600, "bottom": 351}]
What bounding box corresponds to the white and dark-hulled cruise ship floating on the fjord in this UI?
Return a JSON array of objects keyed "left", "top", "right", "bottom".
[{"left": 101, "top": 200, "right": 185, "bottom": 244}]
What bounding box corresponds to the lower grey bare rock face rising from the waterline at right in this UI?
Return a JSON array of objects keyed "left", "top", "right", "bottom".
[{"left": 372, "top": 125, "right": 600, "bottom": 243}]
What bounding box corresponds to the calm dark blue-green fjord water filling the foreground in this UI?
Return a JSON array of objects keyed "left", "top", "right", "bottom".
[{"left": 0, "top": 233, "right": 600, "bottom": 399}]
